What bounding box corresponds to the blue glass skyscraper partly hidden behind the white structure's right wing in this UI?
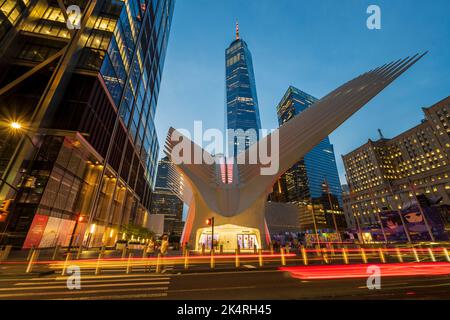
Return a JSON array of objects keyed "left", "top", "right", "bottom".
[{"left": 269, "top": 86, "right": 342, "bottom": 229}]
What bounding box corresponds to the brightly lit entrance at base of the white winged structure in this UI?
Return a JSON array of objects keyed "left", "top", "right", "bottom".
[{"left": 195, "top": 224, "right": 261, "bottom": 252}]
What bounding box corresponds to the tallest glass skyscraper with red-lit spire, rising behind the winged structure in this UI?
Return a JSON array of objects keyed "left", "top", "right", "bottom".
[{"left": 225, "top": 24, "right": 261, "bottom": 156}]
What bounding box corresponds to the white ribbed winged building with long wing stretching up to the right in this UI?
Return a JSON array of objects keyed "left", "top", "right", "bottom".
[{"left": 165, "top": 52, "right": 426, "bottom": 251}]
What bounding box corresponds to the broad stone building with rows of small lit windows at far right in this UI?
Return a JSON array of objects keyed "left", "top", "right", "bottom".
[{"left": 342, "top": 97, "right": 450, "bottom": 229}]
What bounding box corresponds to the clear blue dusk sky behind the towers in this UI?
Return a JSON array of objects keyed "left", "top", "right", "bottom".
[{"left": 156, "top": 0, "right": 450, "bottom": 183}]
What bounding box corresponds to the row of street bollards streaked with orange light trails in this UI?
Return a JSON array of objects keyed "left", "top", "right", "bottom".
[{"left": 0, "top": 245, "right": 450, "bottom": 275}]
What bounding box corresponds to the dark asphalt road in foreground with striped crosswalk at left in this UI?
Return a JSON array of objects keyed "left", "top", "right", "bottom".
[{"left": 0, "top": 270, "right": 450, "bottom": 300}]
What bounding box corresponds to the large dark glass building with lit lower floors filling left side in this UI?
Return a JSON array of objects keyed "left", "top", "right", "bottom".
[{"left": 0, "top": 0, "right": 174, "bottom": 247}]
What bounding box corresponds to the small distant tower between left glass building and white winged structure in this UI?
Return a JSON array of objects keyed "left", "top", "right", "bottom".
[{"left": 151, "top": 157, "right": 184, "bottom": 237}]
